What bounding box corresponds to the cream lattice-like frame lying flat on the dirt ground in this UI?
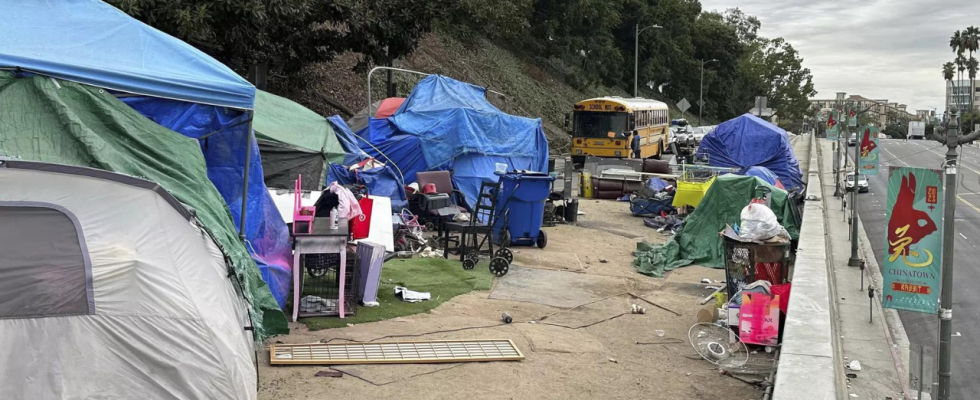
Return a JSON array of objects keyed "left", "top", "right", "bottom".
[{"left": 269, "top": 339, "right": 524, "bottom": 365}]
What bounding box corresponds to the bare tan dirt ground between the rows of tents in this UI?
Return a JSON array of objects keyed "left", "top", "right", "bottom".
[{"left": 259, "top": 173, "right": 762, "bottom": 400}]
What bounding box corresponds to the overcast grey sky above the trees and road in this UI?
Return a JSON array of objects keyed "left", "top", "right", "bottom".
[{"left": 701, "top": 0, "right": 980, "bottom": 112}]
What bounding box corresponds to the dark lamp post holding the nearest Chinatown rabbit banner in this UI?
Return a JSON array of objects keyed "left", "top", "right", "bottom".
[{"left": 938, "top": 106, "right": 960, "bottom": 400}]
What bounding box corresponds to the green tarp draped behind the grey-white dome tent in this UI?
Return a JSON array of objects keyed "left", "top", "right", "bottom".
[{"left": 0, "top": 72, "right": 288, "bottom": 339}]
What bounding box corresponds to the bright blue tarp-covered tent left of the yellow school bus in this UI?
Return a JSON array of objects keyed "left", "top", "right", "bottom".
[{"left": 356, "top": 75, "right": 548, "bottom": 206}]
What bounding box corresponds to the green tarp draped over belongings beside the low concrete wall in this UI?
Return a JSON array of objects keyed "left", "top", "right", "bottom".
[{"left": 633, "top": 174, "right": 800, "bottom": 276}]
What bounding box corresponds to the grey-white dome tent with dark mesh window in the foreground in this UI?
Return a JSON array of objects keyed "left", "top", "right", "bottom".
[{"left": 0, "top": 160, "right": 256, "bottom": 400}]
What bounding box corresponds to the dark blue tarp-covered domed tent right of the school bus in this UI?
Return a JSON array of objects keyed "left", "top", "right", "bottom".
[{"left": 697, "top": 114, "right": 803, "bottom": 191}]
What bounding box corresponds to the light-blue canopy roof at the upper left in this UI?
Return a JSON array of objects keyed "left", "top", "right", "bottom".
[{"left": 0, "top": 0, "right": 261, "bottom": 109}]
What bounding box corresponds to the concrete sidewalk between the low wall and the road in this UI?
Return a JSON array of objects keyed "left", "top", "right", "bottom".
[{"left": 817, "top": 140, "right": 908, "bottom": 400}]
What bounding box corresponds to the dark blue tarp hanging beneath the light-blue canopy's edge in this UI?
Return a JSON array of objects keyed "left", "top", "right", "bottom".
[{"left": 121, "top": 96, "right": 292, "bottom": 307}]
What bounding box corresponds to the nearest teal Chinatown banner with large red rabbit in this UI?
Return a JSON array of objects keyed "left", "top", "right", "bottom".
[{"left": 882, "top": 167, "right": 940, "bottom": 314}]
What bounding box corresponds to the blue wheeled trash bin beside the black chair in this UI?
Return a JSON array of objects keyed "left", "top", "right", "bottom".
[{"left": 493, "top": 172, "right": 555, "bottom": 247}]
